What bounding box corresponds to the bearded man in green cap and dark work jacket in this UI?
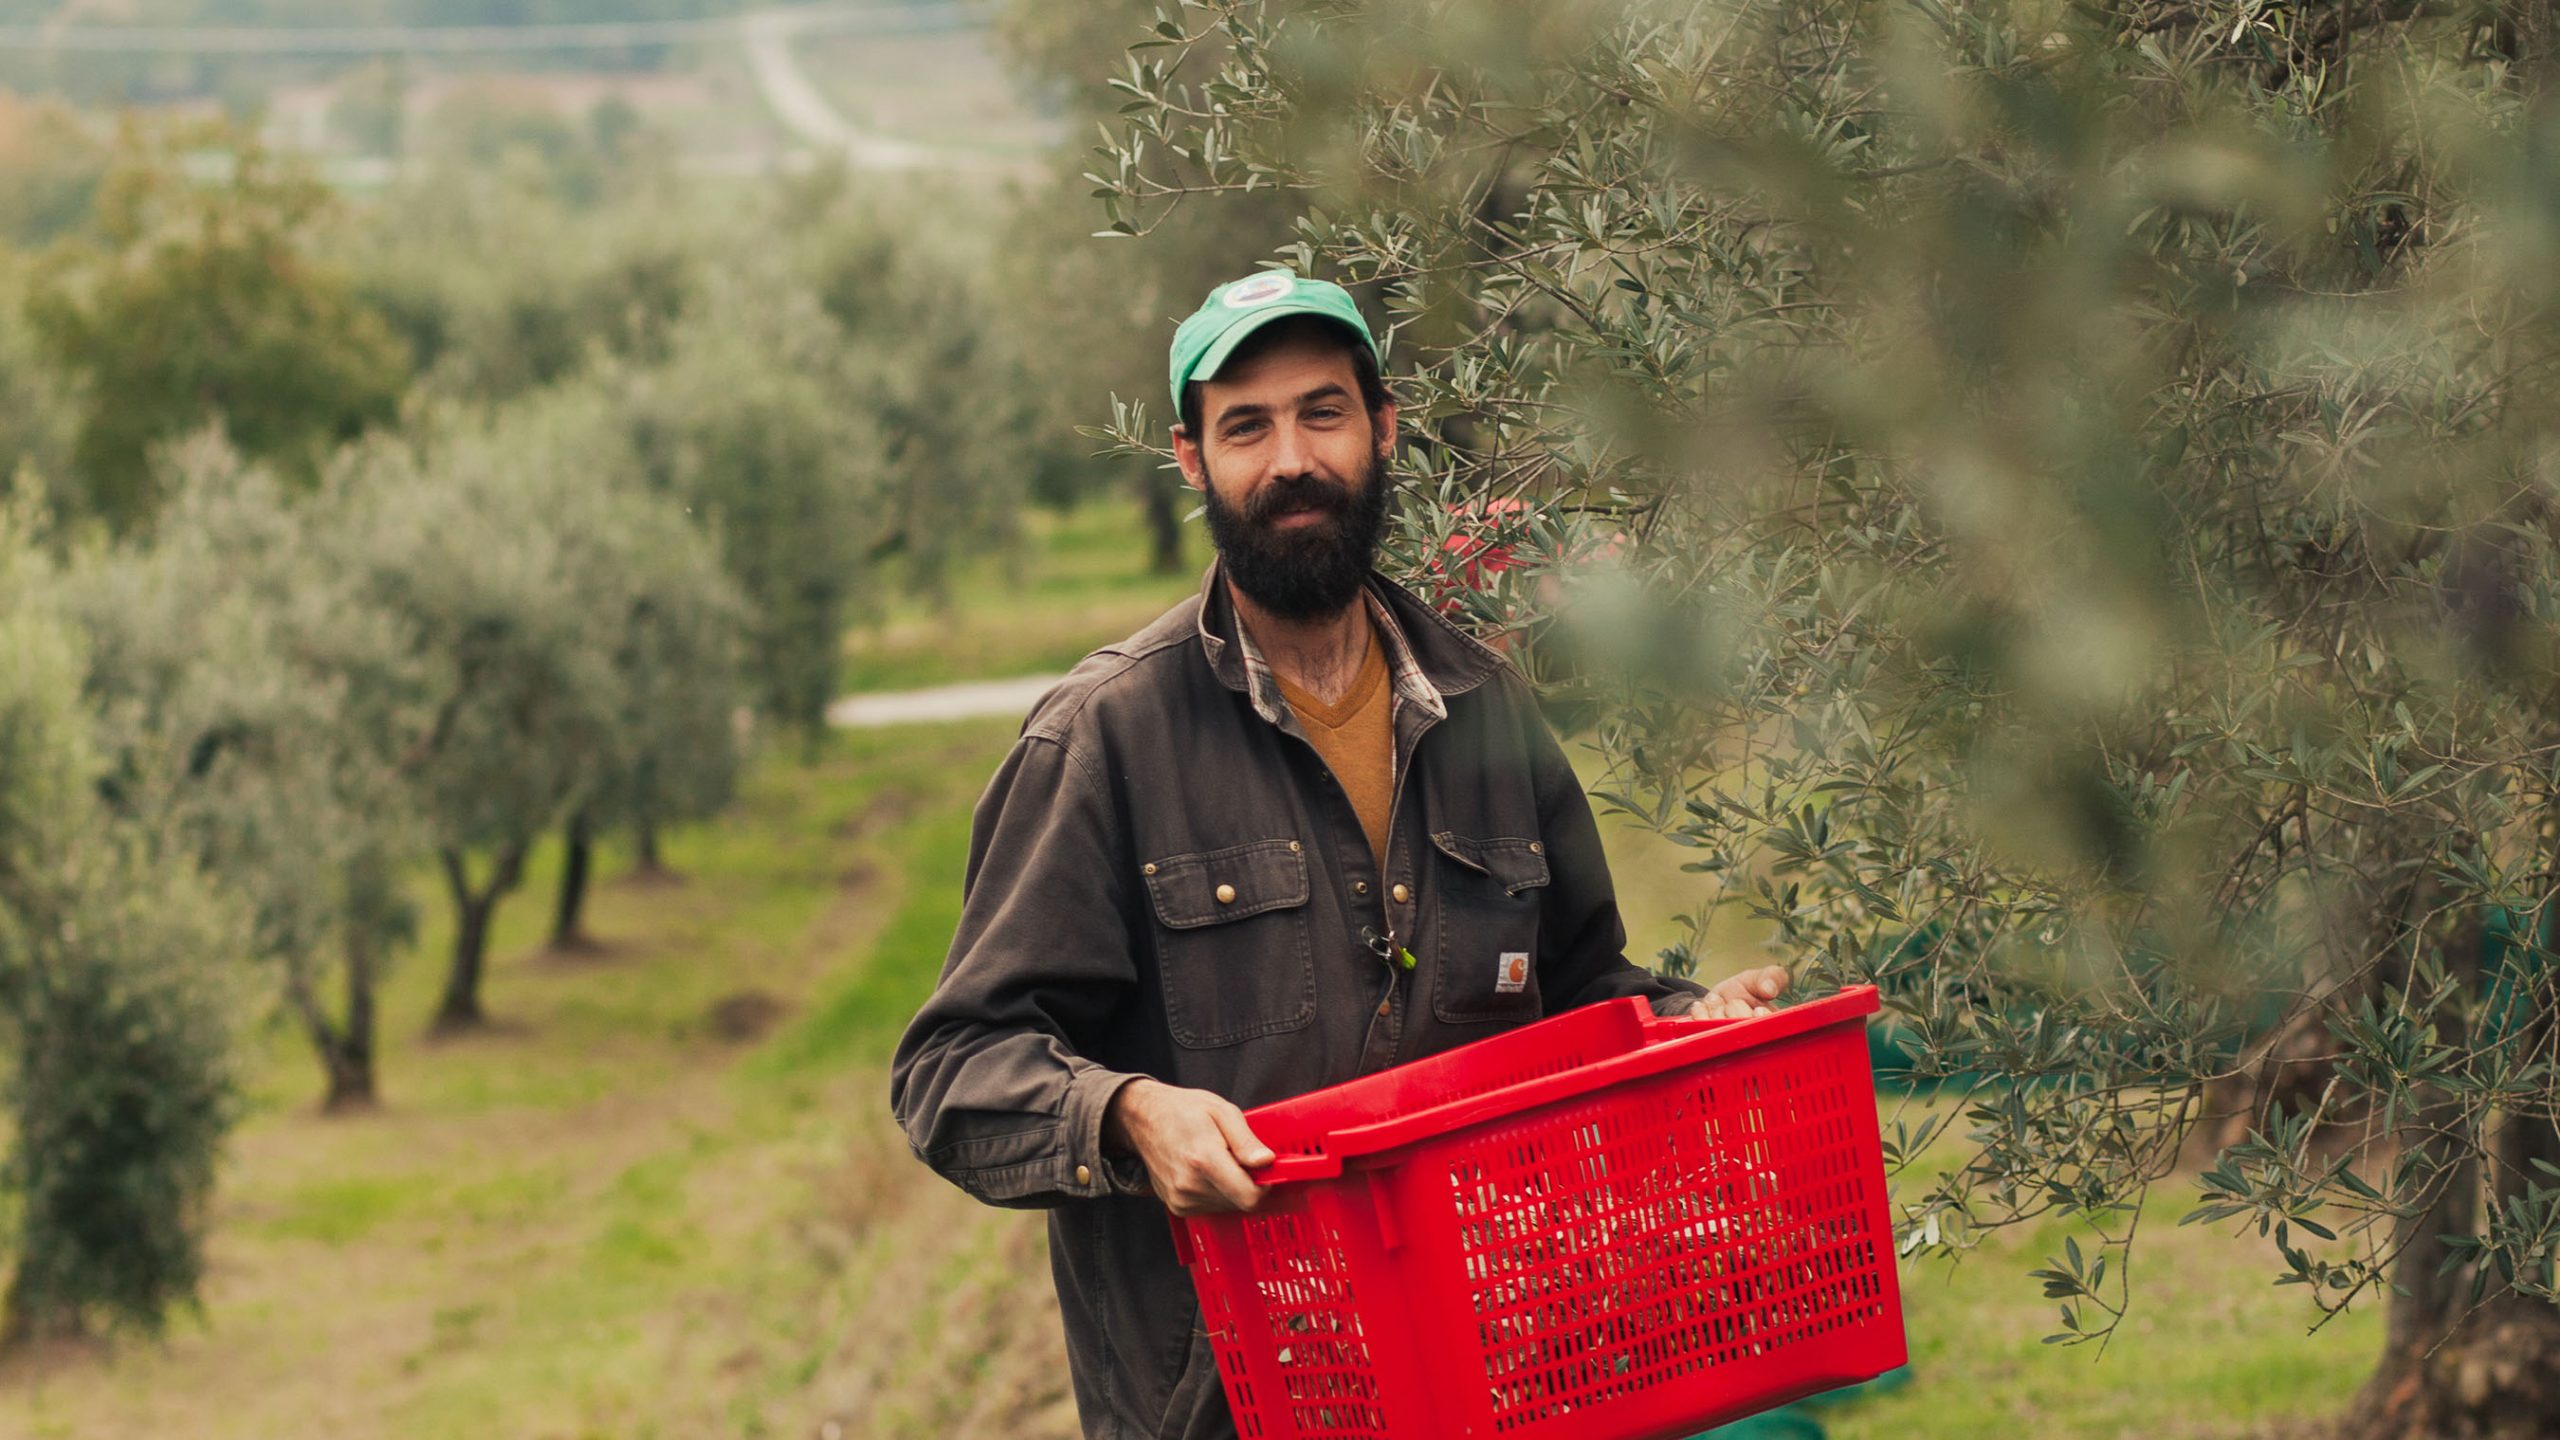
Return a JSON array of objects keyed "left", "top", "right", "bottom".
[{"left": 891, "top": 272, "right": 1787, "bottom": 1440}]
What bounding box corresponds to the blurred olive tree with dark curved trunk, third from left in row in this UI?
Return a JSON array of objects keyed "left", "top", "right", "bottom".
[{"left": 325, "top": 392, "right": 735, "bottom": 1027}]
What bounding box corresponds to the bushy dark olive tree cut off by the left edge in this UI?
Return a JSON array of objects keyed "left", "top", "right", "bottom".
[{"left": 0, "top": 507, "right": 236, "bottom": 1343}]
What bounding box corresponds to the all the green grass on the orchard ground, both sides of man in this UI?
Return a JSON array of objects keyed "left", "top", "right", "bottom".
[{"left": 0, "top": 497, "right": 2378, "bottom": 1440}]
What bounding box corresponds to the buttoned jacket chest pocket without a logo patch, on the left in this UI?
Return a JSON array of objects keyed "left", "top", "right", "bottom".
[{"left": 1144, "top": 840, "right": 1316, "bottom": 1051}]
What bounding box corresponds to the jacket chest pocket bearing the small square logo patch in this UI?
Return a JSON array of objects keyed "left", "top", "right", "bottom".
[{"left": 1431, "top": 830, "right": 1546, "bottom": 1025}]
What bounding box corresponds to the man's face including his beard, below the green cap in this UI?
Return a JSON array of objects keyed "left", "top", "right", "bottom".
[{"left": 1175, "top": 333, "right": 1395, "bottom": 620}]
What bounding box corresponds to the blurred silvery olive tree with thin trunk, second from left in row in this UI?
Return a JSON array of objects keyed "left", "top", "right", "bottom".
[{"left": 67, "top": 433, "right": 417, "bottom": 1109}]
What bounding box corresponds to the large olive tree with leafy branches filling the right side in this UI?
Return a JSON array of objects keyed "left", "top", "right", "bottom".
[{"left": 1096, "top": 0, "right": 2560, "bottom": 1435}]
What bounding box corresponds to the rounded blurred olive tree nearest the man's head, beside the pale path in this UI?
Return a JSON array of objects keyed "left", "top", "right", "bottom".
[{"left": 599, "top": 177, "right": 1049, "bottom": 740}]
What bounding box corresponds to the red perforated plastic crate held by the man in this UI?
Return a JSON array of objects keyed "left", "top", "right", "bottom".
[{"left": 1175, "top": 986, "right": 1905, "bottom": 1440}]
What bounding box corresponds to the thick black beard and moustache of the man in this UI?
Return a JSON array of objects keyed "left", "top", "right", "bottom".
[{"left": 1203, "top": 440, "right": 1393, "bottom": 620}]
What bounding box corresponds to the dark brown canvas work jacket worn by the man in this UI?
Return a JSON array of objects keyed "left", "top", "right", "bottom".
[{"left": 891, "top": 566, "right": 1697, "bottom": 1440}]
